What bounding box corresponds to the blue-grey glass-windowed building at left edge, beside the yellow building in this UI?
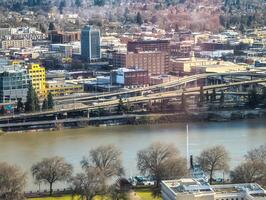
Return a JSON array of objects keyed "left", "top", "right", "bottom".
[{"left": 0, "top": 65, "right": 29, "bottom": 103}]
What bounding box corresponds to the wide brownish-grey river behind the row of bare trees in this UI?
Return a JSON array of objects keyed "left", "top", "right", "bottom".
[{"left": 0, "top": 119, "right": 266, "bottom": 190}]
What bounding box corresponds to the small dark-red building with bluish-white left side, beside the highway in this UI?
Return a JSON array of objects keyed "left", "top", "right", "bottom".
[{"left": 111, "top": 68, "right": 149, "bottom": 88}]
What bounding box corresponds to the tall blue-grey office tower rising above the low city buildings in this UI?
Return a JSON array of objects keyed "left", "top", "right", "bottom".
[{"left": 80, "top": 25, "right": 101, "bottom": 61}]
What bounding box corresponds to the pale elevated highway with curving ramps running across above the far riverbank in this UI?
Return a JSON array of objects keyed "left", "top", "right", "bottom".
[{"left": 0, "top": 72, "right": 266, "bottom": 123}]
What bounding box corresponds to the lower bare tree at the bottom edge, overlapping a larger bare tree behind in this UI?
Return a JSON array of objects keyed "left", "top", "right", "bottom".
[{"left": 70, "top": 167, "right": 103, "bottom": 200}]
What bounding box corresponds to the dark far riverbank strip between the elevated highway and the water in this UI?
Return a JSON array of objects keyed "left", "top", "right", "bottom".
[{"left": 0, "top": 109, "right": 266, "bottom": 134}]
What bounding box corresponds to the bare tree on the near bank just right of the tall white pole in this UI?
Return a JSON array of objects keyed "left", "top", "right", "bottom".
[{"left": 197, "top": 145, "right": 230, "bottom": 184}]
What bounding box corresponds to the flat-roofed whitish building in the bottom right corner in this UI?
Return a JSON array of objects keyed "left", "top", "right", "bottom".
[{"left": 161, "top": 178, "right": 266, "bottom": 200}]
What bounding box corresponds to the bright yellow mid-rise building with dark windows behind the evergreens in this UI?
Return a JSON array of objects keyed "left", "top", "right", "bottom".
[{"left": 28, "top": 64, "right": 46, "bottom": 97}]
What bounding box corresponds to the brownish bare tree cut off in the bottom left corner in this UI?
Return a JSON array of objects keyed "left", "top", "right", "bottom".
[{"left": 0, "top": 162, "right": 26, "bottom": 200}]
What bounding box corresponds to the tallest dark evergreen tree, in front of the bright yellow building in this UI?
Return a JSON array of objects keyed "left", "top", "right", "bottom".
[{"left": 25, "top": 83, "right": 39, "bottom": 112}]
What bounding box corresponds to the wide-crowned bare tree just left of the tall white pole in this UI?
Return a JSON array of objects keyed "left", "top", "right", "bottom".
[{"left": 137, "top": 143, "right": 187, "bottom": 196}]
